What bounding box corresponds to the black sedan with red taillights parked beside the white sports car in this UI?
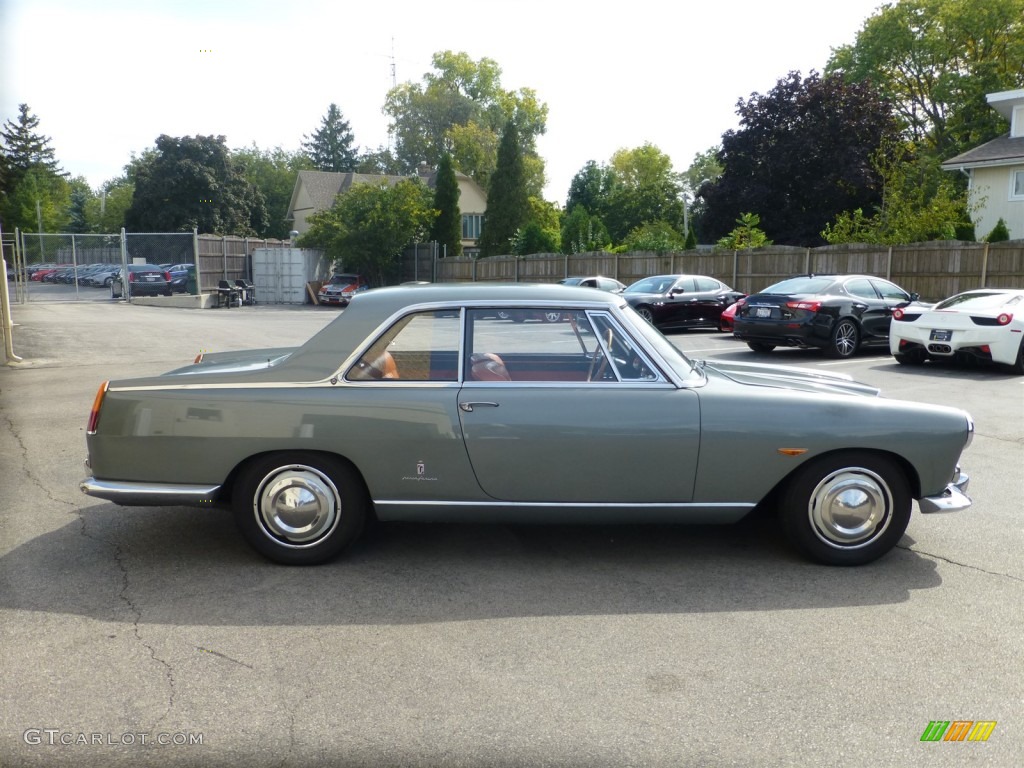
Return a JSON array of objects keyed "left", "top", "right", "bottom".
[{"left": 733, "top": 274, "right": 919, "bottom": 357}]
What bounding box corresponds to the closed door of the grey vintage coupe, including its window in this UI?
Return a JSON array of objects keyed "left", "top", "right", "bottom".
[{"left": 459, "top": 310, "right": 700, "bottom": 506}]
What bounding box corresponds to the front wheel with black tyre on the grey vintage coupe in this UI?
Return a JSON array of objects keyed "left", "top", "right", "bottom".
[{"left": 779, "top": 452, "right": 911, "bottom": 565}]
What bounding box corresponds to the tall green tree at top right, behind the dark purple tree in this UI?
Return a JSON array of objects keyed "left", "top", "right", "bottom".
[{"left": 825, "top": 0, "right": 1024, "bottom": 160}]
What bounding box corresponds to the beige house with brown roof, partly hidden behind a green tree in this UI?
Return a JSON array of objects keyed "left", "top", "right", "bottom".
[{"left": 288, "top": 167, "right": 487, "bottom": 256}]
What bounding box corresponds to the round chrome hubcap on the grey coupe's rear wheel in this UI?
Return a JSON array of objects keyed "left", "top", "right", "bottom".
[{"left": 253, "top": 464, "right": 341, "bottom": 547}]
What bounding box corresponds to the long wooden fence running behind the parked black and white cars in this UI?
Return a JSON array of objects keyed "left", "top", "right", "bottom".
[{"left": 435, "top": 241, "right": 1024, "bottom": 301}]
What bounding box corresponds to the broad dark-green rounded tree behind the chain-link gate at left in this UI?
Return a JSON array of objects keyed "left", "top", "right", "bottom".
[{"left": 125, "top": 135, "right": 267, "bottom": 236}]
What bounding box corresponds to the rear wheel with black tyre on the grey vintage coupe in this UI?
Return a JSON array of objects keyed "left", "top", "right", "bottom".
[{"left": 232, "top": 453, "right": 370, "bottom": 565}]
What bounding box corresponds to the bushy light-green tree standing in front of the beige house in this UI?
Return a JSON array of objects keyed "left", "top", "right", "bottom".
[{"left": 298, "top": 179, "right": 437, "bottom": 286}]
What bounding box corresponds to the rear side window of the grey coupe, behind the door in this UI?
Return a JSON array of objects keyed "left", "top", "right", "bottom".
[{"left": 346, "top": 310, "right": 460, "bottom": 382}]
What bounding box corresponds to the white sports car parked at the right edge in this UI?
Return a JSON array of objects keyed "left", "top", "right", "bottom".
[{"left": 889, "top": 288, "right": 1024, "bottom": 375}]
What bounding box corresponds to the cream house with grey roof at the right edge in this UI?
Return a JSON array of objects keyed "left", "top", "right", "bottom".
[{"left": 942, "top": 89, "right": 1024, "bottom": 240}]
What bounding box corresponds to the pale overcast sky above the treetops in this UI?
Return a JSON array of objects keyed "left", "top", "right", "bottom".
[{"left": 0, "top": 0, "right": 882, "bottom": 203}]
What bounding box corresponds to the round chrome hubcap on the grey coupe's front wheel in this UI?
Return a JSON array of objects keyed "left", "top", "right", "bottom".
[{"left": 807, "top": 467, "right": 893, "bottom": 549}]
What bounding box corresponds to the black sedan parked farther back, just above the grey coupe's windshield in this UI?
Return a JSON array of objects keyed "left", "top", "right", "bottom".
[{"left": 623, "top": 274, "right": 744, "bottom": 331}]
